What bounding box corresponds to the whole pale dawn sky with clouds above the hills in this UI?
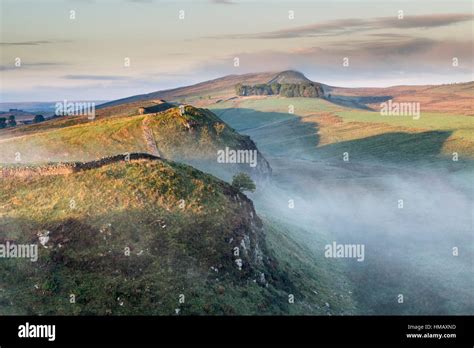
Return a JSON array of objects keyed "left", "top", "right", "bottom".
[{"left": 0, "top": 0, "right": 474, "bottom": 102}]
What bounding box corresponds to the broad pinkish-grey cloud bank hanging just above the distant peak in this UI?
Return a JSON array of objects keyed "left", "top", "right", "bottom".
[{"left": 190, "top": 37, "right": 474, "bottom": 85}]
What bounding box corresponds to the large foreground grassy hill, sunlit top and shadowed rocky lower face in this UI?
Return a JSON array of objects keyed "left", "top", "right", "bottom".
[{"left": 0, "top": 160, "right": 304, "bottom": 315}]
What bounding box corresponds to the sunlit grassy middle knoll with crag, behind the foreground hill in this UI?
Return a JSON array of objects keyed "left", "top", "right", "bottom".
[{"left": 0, "top": 106, "right": 260, "bottom": 163}]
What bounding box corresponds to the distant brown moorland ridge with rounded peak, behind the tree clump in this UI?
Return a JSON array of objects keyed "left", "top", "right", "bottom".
[{"left": 98, "top": 70, "right": 474, "bottom": 115}]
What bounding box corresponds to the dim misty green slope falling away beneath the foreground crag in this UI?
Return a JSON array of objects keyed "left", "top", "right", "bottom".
[{"left": 264, "top": 214, "right": 357, "bottom": 315}]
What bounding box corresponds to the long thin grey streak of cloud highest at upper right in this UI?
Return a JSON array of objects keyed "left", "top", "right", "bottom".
[{"left": 216, "top": 13, "right": 474, "bottom": 39}]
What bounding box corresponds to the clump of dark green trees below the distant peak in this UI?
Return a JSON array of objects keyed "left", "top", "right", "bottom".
[{"left": 235, "top": 82, "right": 324, "bottom": 98}]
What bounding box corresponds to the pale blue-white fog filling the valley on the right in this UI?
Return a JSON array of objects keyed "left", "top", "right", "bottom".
[{"left": 251, "top": 157, "right": 474, "bottom": 314}]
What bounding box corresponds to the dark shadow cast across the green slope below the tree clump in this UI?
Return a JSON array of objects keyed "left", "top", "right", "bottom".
[{"left": 214, "top": 106, "right": 452, "bottom": 163}]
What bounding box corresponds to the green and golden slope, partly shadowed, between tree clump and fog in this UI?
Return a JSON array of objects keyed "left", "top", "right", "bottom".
[{"left": 209, "top": 97, "right": 474, "bottom": 159}]
